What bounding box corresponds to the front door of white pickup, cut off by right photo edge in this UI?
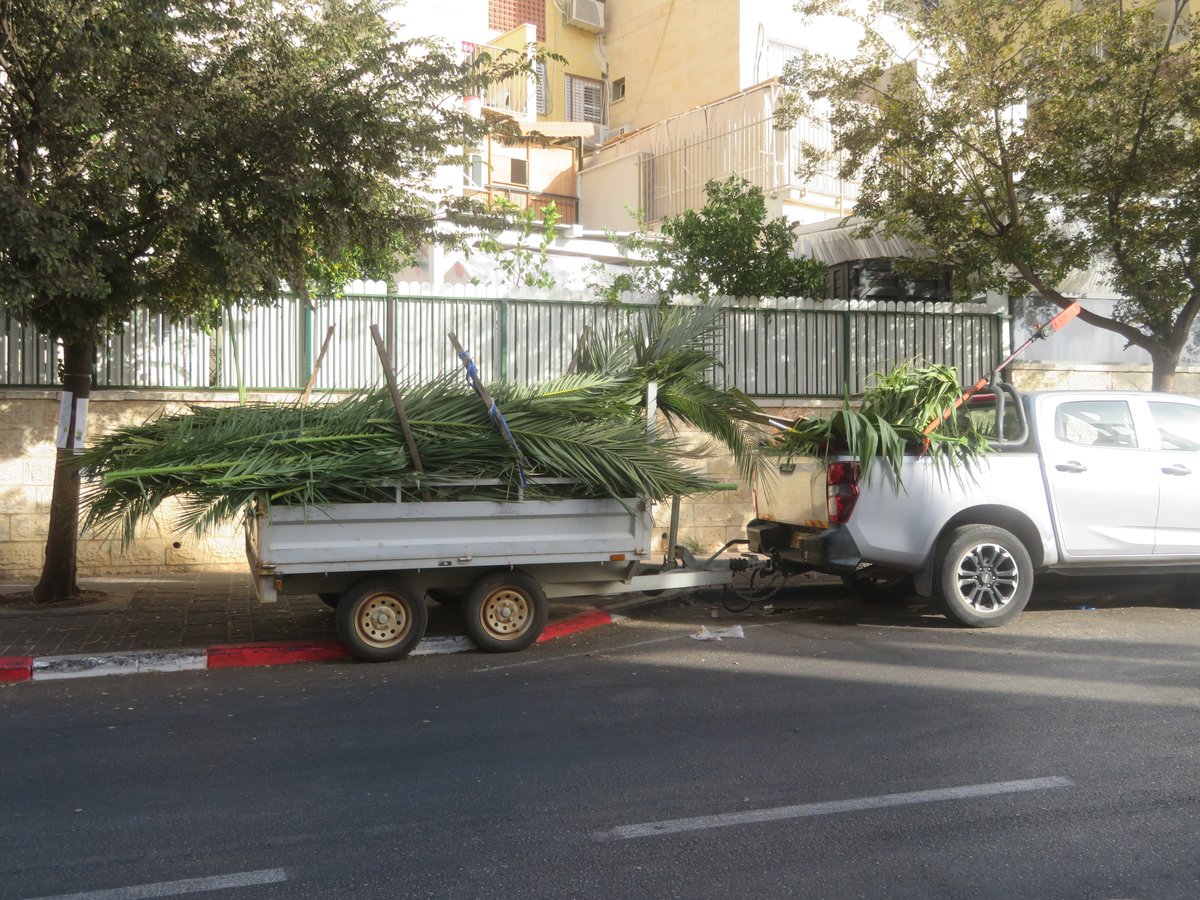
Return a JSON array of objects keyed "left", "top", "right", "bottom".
[{"left": 1148, "top": 400, "right": 1200, "bottom": 557}]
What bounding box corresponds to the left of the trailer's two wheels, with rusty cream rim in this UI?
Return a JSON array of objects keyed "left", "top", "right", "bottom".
[{"left": 335, "top": 578, "right": 428, "bottom": 662}]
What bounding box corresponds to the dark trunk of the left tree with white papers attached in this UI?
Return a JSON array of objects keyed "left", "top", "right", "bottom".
[{"left": 34, "top": 341, "right": 95, "bottom": 602}]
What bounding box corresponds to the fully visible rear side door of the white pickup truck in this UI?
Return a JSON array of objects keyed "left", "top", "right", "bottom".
[{"left": 1039, "top": 397, "right": 1160, "bottom": 559}]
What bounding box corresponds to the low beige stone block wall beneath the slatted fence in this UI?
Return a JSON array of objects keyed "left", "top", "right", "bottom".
[{"left": 0, "top": 390, "right": 820, "bottom": 582}]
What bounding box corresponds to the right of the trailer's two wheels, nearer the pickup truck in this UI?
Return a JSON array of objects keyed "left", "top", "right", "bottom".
[{"left": 463, "top": 571, "right": 550, "bottom": 653}]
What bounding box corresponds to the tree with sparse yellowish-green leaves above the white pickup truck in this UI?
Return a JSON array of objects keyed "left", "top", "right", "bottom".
[{"left": 781, "top": 0, "right": 1200, "bottom": 390}]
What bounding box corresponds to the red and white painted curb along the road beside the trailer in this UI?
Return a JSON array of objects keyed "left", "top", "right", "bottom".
[{"left": 0, "top": 610, "right": 625, "bottom": 682}]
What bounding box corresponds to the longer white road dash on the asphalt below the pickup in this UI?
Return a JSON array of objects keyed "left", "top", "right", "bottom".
[{"left": 593, "top": 776, "right": 1075, "bottom": 840}]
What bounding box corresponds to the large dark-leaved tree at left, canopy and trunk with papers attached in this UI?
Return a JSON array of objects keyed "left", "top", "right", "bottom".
[{"left": 0, "top": 0, "right": 529, "bottom": 600}]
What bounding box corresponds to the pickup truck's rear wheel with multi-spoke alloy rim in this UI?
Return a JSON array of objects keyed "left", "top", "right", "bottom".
[{"left": 934, "top": 524, "right": 1033, "bottom": 628}]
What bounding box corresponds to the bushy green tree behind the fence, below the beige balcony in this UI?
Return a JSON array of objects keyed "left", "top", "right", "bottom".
[{"left": 588, "top": 175, "right": 826, "bottom": 299}]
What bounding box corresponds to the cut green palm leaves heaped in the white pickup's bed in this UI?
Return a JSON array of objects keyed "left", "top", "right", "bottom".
[{"left": 772, "top": 361, "right": 990, "bottom": 480}]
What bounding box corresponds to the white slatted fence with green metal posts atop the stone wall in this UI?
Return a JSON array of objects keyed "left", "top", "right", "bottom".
[{"left": 0, "top": 294, "right": 1004, "bottom": 398}]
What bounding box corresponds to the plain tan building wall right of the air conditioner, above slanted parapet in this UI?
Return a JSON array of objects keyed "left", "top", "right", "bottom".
[{"left": 605, "top": 0, "right": 740, "bottom": 128}]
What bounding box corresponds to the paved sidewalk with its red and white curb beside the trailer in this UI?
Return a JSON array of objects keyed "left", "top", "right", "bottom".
[{"left": 0, "top": 572, "right": 628, "bottom": 682}]
